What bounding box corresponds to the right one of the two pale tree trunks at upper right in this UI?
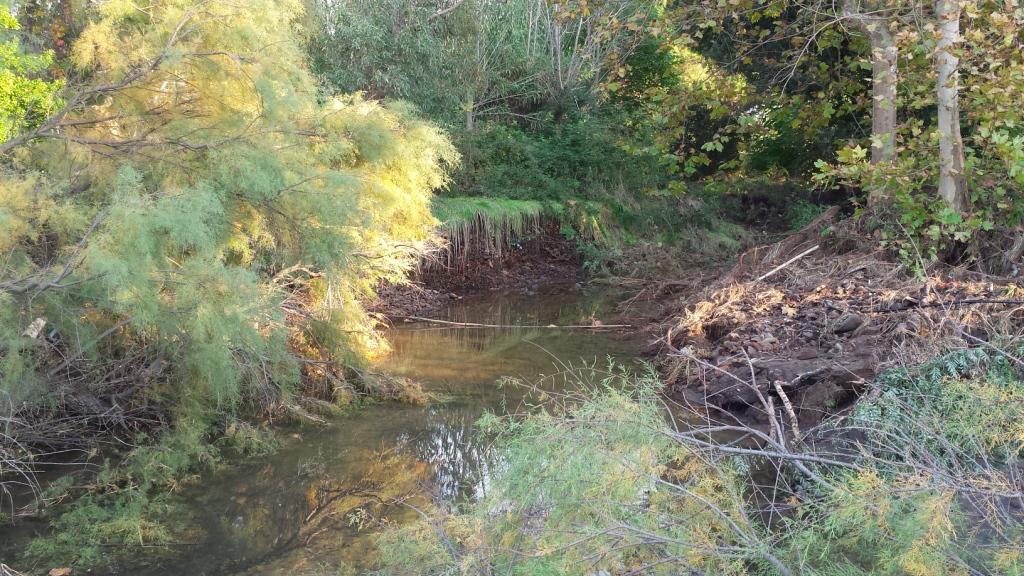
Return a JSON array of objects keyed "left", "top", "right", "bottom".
[{"left": 935, "top": 0, "right": 969, "bottom": 211}]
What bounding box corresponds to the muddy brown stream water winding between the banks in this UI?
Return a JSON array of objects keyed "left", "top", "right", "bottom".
[{"left": 110, "top": 291, "right": 638, "bottom": 576}]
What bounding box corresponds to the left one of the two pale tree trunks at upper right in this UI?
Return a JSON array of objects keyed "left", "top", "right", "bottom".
[{"left": 843, "top": 0, "right": 899, "bottom": 206}]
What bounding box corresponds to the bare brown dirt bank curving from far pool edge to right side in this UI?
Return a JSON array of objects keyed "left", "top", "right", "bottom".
[{"left": 372, "top": 209, "right": 1024, "bottom": 429}]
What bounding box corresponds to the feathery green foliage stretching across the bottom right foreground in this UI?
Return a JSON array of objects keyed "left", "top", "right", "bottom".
[{"left": 380, "top": 353, "right": 1024, "bottom": 576}]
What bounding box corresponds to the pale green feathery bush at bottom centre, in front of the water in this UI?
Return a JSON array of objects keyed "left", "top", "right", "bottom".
[{"left": 380, "top": 366, "right": 770, "bottom": 575}]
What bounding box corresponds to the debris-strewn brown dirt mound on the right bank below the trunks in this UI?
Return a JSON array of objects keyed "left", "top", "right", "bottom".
[{"left": 652, "top": 211, "right": 1024, "bottom": 429}]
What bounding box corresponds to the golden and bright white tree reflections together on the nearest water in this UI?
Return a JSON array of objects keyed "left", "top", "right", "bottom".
[{"left": 154, "top": 404, "right": 487, "bottom": 574}]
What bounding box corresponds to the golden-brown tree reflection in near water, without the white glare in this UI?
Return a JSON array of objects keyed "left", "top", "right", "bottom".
[{"left": 154, "top": 449, "right": 430, "bottom": 575}]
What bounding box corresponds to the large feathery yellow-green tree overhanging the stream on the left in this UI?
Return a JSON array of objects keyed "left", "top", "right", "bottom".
[{"left": 0, "top": 0, "right": 456, "bottom": 414}]
